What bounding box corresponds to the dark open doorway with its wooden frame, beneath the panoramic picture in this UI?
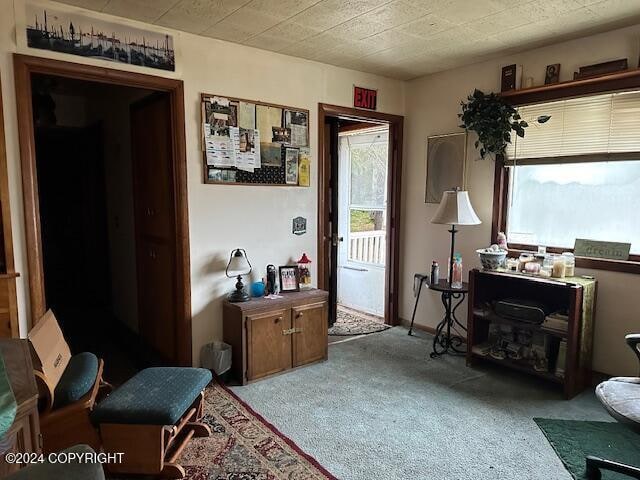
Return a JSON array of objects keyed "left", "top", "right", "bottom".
[{"left": 15, "top": 55, "right": 191, "bottom": 383}]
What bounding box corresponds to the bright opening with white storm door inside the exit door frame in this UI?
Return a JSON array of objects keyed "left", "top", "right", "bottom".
[{"left": 333, "top": 122, "right": 389, "bottom": 334}]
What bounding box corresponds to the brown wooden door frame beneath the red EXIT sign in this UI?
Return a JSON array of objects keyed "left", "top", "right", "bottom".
[{"left": 317, "top": 103, "right": 404, "bottom": 325}]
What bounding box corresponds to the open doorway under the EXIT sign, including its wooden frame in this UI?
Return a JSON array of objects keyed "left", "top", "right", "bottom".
[{"left": 318, "top": 104, "right": 403, "bottom": 335}]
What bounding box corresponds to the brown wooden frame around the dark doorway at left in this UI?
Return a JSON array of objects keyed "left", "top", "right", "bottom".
[{"left": 13, "top": 54, "right": 192, "bottom": 366}]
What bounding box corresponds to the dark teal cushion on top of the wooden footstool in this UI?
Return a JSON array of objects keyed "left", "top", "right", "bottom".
[{"left": 91, "top": 367, "right": 211, "bottom": 425}]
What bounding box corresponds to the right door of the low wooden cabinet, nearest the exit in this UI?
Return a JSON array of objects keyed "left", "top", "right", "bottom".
[{"left": 291, "top": 302, "right": 328, "bottom": 367}]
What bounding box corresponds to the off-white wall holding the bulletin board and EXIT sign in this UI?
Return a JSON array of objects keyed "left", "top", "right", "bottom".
[{"left": 0, "top": 0, "right": 404, "bottom": 363}]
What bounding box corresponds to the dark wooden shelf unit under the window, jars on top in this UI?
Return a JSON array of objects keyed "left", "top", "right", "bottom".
[{"left": 467, "top": 270, "right": 597, "bottom": 399}]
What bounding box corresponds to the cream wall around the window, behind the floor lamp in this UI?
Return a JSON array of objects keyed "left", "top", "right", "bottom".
[{"left": 400, "top": 26, "right": 640, "bottom": 375}]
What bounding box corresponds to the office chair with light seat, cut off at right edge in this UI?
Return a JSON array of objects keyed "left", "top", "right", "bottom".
[{"left": 587, "top": 334, "right": 640, "bottom": 479}]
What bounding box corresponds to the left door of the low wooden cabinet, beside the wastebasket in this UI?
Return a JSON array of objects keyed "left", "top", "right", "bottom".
[{"left": 246, "top": 309, "right": 292, "bottom": 380}]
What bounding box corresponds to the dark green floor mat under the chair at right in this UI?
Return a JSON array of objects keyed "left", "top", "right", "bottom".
[{"left": 533, "top": 418, "right": 640, "bottom": 480}]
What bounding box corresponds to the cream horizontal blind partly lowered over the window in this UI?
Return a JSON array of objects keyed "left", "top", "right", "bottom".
[{"left": 506, "top": 91, "right": 640, "bottom": 164}]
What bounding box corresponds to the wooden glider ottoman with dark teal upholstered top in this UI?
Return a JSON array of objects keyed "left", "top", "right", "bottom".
[{"left": 91, "top": 367, "right": 211, "bottom": 478}]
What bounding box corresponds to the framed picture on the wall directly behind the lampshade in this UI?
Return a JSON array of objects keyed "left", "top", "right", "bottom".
[{"left": 424, "top": 132, "right": 467, "bottom": 203}]
